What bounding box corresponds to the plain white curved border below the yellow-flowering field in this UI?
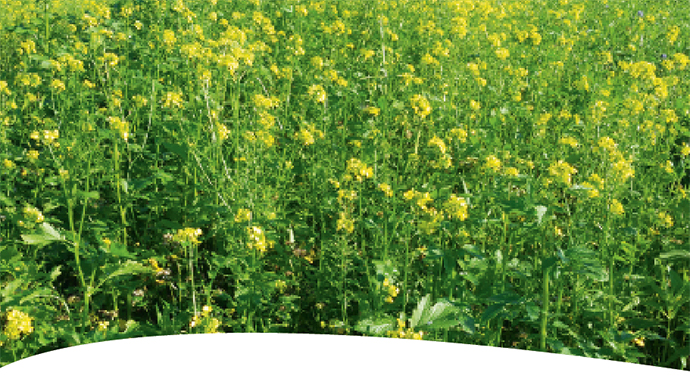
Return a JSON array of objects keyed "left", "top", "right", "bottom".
[{"left": 0, "top": 333, "right": 690, "bottom": 379}]
